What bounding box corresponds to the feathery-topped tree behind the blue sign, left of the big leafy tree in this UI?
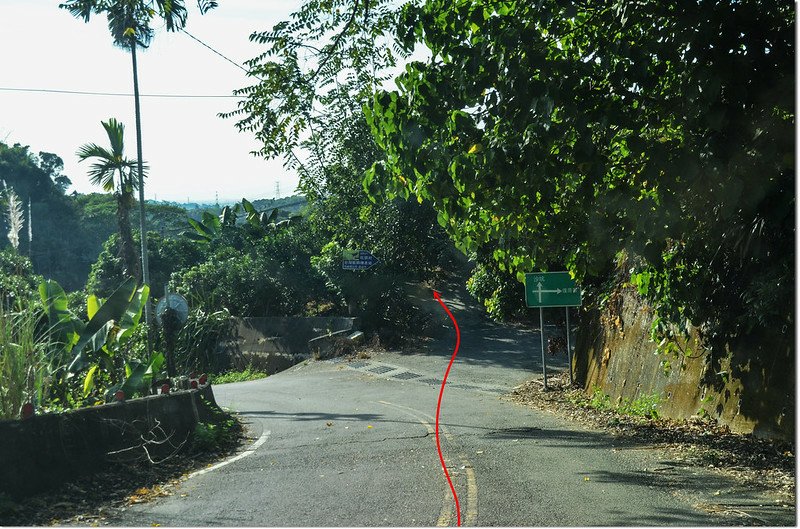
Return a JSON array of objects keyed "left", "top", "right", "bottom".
[{"left": 225, "top": 0, "right": 448, "bottom": 328}]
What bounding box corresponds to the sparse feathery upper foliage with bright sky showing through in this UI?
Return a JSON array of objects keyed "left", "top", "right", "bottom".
[{"left": 221, "top": 0, "right": 409, "bottom": 166}]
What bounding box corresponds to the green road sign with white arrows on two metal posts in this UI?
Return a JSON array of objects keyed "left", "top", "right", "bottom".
[{"left": 525, "top": 272, "right": 581, "bottom": 389}]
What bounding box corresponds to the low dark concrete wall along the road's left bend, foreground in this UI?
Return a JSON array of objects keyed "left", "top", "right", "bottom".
[{"left": 0, "top": 386, "right": 217, "bottom": 498}]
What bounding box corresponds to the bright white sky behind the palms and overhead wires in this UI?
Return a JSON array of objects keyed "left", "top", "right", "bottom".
[{"left": 0, "top": 0, "right": 300, "bottom": 202}]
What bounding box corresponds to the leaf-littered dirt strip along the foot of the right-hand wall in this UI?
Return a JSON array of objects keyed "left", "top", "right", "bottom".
[{"left": 507, "top": 374, "right": 795, "bottom": 505}]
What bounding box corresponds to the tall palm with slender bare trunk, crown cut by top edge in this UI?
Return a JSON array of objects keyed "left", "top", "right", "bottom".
[{"left": 58, "top": 0, "right": 217, "bottom": 327}]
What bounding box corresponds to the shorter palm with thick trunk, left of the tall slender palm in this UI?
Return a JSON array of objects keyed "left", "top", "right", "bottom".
[{"left": 76, "top": 118, "right": 144, "bottom": 280}]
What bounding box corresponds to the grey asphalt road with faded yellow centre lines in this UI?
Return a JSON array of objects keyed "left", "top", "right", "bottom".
[{"left": 110, "top": 284, "right": 780, "bottom": 526}]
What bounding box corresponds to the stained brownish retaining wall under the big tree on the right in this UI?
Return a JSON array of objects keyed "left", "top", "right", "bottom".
[{"left": 573, "top": 287, "right": 795, "bottom": 439}]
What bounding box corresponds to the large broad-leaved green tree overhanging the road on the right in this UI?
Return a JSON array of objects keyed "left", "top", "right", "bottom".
[{"left": 365, "top": 0, "right": 795, "bottom": 351}]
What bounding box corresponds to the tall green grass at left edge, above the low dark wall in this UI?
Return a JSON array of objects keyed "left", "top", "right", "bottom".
[{"left": 0, "top": 302, "right": 51, "bottom": 419}]
